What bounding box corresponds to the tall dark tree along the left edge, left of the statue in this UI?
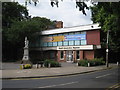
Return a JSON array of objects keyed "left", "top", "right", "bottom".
[{"left": 2, "top": 2, "right": 29, "bottom": 61}]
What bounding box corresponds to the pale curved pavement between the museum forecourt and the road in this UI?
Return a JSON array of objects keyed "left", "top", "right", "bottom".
[{"left": 0, "top": 63, "right": 118, "bottom": 79}]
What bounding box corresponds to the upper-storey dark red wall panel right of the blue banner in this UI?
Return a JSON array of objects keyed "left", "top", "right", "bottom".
[{"left": 86, "top": 30, "right": 100, "bottom": 45}]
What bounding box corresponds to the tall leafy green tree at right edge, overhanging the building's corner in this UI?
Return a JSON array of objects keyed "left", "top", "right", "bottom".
[{"left": 91, "top": 2, "right": 120, "bottom": 62}]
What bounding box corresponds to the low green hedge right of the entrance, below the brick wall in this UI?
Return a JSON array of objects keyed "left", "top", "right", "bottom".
[{"left": 78, "top": 58, "right": 105, "bottom": 67}]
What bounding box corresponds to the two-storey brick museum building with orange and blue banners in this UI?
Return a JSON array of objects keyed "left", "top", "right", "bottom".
[{"left": 31, "top": 24, "right": 101, "bottom": 62}]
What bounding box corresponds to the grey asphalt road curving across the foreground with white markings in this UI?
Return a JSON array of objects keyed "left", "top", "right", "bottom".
[{"left": 2, "top": 68, "right": 120, "bottom": 88}]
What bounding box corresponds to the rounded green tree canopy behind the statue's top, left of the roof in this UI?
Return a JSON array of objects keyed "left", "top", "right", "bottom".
[{"left": 6, "top": 17, "right": 52, "bottom": 43}]
